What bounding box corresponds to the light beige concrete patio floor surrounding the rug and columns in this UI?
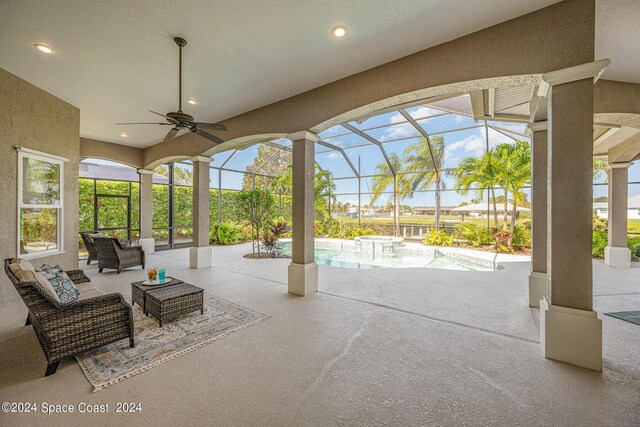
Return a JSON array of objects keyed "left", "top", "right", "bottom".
[{"left": 0, "top": 245, "right": 640, "bottom": 426}]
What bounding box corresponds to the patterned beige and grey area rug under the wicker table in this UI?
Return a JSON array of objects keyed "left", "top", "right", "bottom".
[{"left": 76, "top": 292, "right": 270, "bottom": 392}]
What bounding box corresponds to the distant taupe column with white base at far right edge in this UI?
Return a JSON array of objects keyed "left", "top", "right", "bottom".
[{"left": 604, "top": 162, "right": 633, "bottom": 268}]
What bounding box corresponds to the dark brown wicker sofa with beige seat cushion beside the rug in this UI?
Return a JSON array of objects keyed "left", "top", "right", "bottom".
[{"left": 4, "top": 259, "right": 135, "bottom": 376}]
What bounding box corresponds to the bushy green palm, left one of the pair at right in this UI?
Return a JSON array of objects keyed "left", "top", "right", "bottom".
[{"left": 452, "top": 152, "right": 500, "bottom": 228}]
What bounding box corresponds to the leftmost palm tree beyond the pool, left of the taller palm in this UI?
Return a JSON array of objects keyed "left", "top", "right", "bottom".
[{"left": 369, "top": 153, "right": 413, "bottom": 236}]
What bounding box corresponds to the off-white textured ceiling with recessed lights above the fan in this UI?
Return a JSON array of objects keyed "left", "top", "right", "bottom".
[{"left": 0, "top": 0, "right": 640, "bottom": 147}]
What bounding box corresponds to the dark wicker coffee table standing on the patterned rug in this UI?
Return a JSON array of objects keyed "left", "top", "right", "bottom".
[{"left": 131, "top": 279, "right": 204, "bottom": 327}]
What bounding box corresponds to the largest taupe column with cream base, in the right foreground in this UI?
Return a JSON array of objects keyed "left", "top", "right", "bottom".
[{"left": 540, "top": 60, "right": 609, "bottom": 371}]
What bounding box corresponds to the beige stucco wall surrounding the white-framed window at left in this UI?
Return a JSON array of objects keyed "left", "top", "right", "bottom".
[{"left": 0, "top": 68, "right": 80, "bottom": 305}]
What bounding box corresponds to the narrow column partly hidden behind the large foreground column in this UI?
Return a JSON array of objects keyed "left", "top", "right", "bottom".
[{"left": 529, "top": 120, "right": 548, "bottom": 307}]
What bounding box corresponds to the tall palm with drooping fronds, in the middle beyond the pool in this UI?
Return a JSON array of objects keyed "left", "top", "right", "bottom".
[{"left": 404, "top": 136, "right": 445, "bottom": 230}]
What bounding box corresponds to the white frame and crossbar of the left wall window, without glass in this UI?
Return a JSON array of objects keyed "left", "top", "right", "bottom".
[{"left": 16, "top": 146, "right": 69, "bottom": 259}]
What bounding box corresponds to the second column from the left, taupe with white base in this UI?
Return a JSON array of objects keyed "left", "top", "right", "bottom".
[{"left": 189, "top": 156, "right": 211, "bottom": 268}]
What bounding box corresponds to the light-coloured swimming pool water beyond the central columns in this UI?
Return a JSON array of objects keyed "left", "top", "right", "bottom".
[{"left": 281, "top": 239, "right": 504, "bottom": 271}]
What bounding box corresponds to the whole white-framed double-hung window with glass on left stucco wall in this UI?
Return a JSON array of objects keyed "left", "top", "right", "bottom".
[{"left": 18, "top": 148, "right": 66, "bottom": 258}]
